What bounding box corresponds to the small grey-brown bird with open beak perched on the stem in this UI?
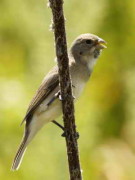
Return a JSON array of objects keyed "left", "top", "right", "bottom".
[{"left": 12, "top": 34, "right": 106, "bottom": 170}]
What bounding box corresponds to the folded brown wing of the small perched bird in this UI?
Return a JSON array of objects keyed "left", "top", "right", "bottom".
[{"left": 21, "top": 66, "right": 59, "bottom": 124}]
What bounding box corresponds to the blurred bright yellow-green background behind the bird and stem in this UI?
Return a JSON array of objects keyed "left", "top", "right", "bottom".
[{"left": 0, "top": 0, "right": 135, "bottom": 180}]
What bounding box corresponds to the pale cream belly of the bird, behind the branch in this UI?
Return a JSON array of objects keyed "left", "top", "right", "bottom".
[{"left": 29, "top": 81, "right": 85, "bottom": 140}]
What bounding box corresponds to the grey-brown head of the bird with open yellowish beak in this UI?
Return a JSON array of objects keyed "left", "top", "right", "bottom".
[{"left": 70, "top": 34, "right": 106, "bottom": 68}]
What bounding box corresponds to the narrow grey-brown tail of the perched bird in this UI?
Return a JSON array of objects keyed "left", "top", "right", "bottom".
[{"left": 11, "top": 133, "right": 28, "bottom": 171}]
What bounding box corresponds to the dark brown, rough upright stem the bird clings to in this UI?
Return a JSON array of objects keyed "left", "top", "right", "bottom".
[{"left": 49, "top": 0, "right": 82, "bottom": 180}]
